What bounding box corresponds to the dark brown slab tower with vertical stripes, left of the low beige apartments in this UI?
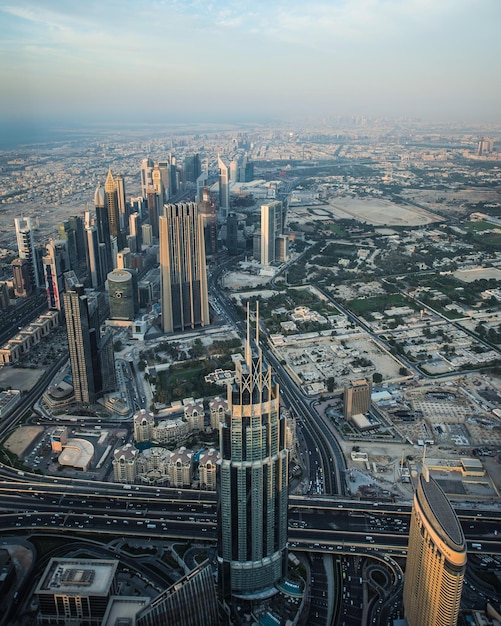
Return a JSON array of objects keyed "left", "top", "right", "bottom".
[{"left": 64, "top": 285, "right": 102, "bottom": 404}]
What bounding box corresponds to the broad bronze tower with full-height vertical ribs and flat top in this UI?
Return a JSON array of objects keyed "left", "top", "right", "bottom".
[{"left": 160, "top": 202, "right": 210, "bottom": 333}]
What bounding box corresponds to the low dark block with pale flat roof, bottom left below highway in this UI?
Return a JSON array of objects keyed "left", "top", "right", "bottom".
[{"left": 35, "top": 557, "right": 119, "bottom": 626}]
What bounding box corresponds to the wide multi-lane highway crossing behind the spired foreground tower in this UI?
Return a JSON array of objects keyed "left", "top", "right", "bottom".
[{"left": 0, "top": 472, "right": 501, "bottom": 556}]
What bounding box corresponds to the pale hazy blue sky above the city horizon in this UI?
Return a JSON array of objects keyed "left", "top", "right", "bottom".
[{"left": 0, "top": 0, "right": 501, "bottom": 125}]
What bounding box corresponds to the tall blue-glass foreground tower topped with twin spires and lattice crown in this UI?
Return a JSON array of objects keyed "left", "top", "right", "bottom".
[{"left": 217, "top": 310, "right": 289, "bottom": 601}]
